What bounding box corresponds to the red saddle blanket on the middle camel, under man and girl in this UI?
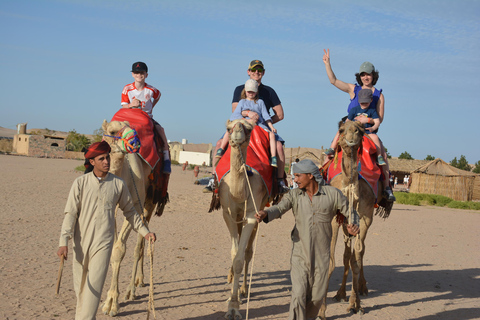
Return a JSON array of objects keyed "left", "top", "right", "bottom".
[{"left": 215, "top": 126, "right": 273, "bottom": 196}]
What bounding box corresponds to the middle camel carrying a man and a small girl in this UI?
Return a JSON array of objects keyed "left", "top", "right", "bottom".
[{"left": 218, "top": 119, "right": 268, "bottom": 320}]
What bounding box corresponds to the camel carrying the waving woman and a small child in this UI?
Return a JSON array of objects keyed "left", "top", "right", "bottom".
[{"left": 319, "top": 121, "right": 391, "bottom": 319}]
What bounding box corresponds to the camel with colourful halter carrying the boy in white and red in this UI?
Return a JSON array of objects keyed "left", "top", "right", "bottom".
[{"left": 102, "top": 120, "right": 166, "bottom": 317}]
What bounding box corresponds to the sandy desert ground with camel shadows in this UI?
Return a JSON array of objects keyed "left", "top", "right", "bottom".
[{"left": 0, "top": 155, "right": 480, "bottom": 320}]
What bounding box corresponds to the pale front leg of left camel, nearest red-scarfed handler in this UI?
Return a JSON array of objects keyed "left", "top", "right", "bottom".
[{"left": 102, "top": 219, "right": 132, "bottom": 317}]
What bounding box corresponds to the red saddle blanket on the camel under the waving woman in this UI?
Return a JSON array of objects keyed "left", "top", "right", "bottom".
[{"left": 325, "top": 136, "right": 382, "bottom": 198}]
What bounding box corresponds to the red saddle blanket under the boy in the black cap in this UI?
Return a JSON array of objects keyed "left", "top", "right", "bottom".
[{"left": 112, "top": 108, "right": 160, "bottom": 170}]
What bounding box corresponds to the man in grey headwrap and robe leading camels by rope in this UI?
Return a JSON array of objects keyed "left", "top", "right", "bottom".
[{"left": 256, "top": 159, "right": 360, "bottom": 320}]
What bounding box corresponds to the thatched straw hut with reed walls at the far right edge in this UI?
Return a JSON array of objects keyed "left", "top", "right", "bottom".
[{"left": 410, "top": 158, "right": 477, "bottom": 201}]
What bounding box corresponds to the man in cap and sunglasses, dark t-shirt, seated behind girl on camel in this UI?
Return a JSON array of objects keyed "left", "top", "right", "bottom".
[{"left": 203, "top": 60, "right": 288, "bottom": 192}]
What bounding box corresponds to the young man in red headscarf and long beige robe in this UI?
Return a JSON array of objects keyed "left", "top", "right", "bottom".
[{"left": 57, "top": 141, "right": 156, "bottom": 320}]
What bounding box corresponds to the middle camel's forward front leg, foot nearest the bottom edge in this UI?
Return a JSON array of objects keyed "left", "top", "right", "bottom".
[{"left": 225, "top": 220, "right": 257, "bottom": 320}]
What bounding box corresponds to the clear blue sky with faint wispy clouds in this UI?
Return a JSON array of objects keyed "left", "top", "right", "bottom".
[{"left": 0, "top": 0, "right": 480, "bottom": 164}]
